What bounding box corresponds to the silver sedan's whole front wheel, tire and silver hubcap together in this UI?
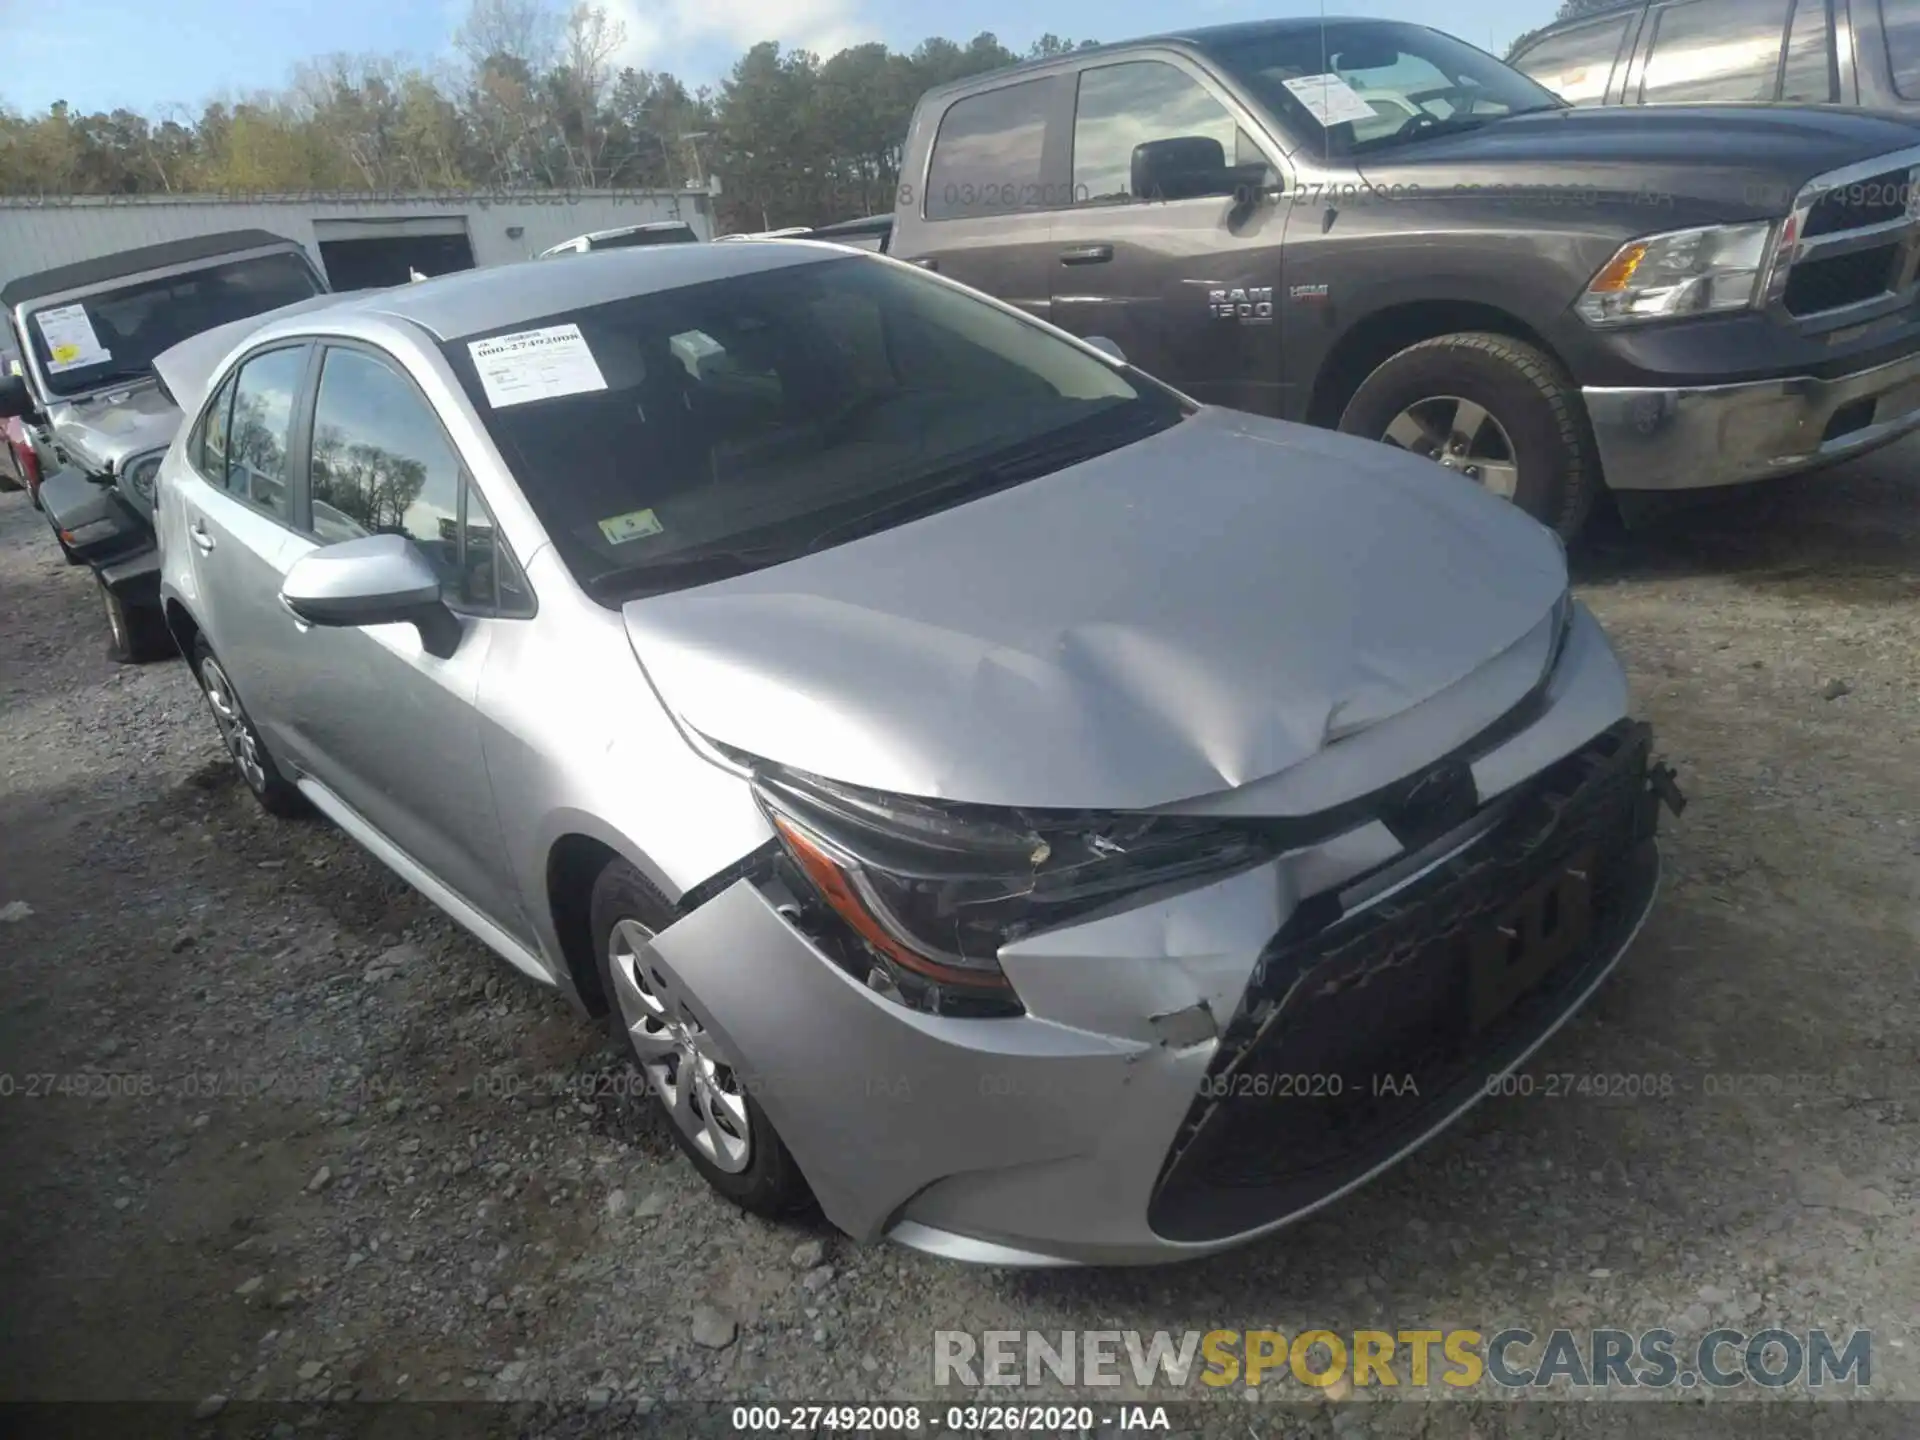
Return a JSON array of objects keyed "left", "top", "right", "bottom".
[{"left": 588, "top": 860, "right": 812, "bottom": 1219}]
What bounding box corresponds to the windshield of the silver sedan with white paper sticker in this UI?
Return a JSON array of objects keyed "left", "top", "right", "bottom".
[{"left": 444, "top": 255, "right": 1185, "bottom": 599}]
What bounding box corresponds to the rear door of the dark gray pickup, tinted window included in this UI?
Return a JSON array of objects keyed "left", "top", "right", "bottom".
[{"left": 897, "top": 71, "right": 1073, "bottom": 319}]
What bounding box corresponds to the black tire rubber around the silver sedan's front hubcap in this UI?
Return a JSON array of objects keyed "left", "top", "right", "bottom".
[{"left": 588, "top": 860, "right": 814, "bottom": 1219}]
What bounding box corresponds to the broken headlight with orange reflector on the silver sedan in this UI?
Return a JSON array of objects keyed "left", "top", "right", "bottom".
[{"left": 753, "top": 779, "right": 1284, "bottom": 1014}]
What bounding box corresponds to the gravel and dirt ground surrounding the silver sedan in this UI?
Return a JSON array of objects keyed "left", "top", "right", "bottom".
[{"left": 0, "top": 464, "right": 1920, "bottom": 1434}]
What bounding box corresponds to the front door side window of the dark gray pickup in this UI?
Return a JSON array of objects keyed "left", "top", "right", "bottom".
[{"left": 1073, "top": 60, "right": 1261, "bottom": 204}]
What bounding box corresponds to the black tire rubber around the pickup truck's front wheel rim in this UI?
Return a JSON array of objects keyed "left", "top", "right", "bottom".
[{"left": 1340, "top": 332, "right": 1601, "bottom": 540}]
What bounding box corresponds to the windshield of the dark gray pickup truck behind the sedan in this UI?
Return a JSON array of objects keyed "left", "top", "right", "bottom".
[{"left": 1204, "top": 21, "right": 1565, "bottom": 157}]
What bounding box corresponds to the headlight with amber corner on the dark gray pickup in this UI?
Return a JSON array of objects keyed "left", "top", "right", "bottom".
[{"left": 1574, "top": 221, "right": 1774, "bottom": 324}]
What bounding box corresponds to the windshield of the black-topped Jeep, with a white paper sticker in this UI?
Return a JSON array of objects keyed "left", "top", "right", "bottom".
[{"left": 27, "top": 253, "right": 323, "bottom": 396}]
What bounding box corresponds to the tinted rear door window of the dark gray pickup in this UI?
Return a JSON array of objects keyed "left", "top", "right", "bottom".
[{"left": 924, "top": 79, "right": 1052, "bottom": 221}]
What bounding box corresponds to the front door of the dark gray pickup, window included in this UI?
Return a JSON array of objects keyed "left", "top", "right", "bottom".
[{"left": 1050, "top": 54, "right": 1286, "bottom": 415}]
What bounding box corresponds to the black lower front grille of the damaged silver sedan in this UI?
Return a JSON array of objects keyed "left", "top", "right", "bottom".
[{"left": 1148, "top": 722, "right": 1655, "bottom": 1240}]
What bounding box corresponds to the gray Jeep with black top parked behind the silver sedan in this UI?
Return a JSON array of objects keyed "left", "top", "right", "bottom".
[{"left": 0, "top": 230, "right": 326, "bottom": 660}]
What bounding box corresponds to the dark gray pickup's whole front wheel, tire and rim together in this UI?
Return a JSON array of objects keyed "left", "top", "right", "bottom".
[{"left": 1340, "top": 332, "right": 1599, "bottom": 540}]
